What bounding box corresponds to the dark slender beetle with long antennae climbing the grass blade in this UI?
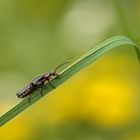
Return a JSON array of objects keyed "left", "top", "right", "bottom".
[{"left": 16, "top": 61, "right": 69, "bottom": 99}]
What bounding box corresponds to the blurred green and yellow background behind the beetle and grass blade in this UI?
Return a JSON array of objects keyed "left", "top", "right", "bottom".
[{"left": 0, "top": 0, "right": 140, "bottom": 140}]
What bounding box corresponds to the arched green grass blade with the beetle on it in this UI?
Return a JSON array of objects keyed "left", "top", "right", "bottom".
[{"left": 0, "top": 36, "right": 140, "bottom": 126}]
